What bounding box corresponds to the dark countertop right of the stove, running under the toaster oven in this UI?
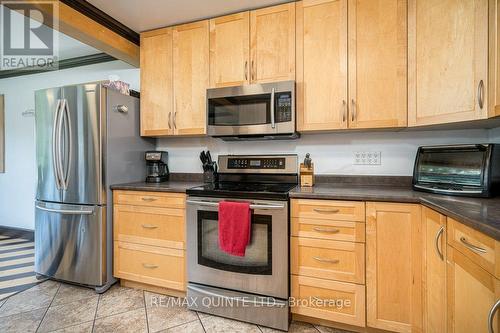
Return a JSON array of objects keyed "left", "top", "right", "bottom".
[{"left": 290, "top": 184, "right": 500, "bottom": 241}]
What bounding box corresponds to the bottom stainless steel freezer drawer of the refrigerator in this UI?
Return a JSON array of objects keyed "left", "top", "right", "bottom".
[{"left": 35, "top": 201, "right": 106, "bottom": 286}]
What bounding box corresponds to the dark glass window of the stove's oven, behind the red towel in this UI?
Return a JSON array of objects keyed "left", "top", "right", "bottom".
[{"left": 198, "top": 211, "right": 272, "bottom": 275}]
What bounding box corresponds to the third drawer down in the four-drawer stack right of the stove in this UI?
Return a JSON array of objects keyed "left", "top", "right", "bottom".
[{"left": 291, "top": 237, "right": 365, "bottom": 284}]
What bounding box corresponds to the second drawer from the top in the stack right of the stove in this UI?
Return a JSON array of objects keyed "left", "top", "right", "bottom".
[{"left": 292, "top": 217, "right": 365, "bottom": 243}]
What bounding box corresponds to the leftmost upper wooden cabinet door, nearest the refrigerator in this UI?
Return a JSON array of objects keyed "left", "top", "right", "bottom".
[{"left": 141, "top": 28, "right": 173, "bottom": 136}]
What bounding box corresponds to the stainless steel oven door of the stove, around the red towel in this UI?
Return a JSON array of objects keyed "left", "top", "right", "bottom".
[{"left": 187, "top": 197, "right": 288, "bottom": 298}]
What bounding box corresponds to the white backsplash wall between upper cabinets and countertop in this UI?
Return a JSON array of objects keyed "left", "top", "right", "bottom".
[{"left": 157, "top": 128, "right": 500, "bottom": 176}]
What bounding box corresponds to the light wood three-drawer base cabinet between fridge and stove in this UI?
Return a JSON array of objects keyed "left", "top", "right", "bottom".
[{"left": 113, "top": 191, "right": 186, "bottom": 296}]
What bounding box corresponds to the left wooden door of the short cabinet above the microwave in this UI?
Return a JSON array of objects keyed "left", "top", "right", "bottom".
[{"left": 210, "top": 12, "right": 250, "bottom": 87}]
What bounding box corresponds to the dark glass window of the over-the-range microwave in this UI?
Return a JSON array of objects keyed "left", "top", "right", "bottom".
[{"left": 208, "top": 94, "right": 271, "bottom": 126}]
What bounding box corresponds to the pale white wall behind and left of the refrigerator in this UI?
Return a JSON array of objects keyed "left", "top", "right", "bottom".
[{"left": 0, "top": 61, "right": 139, "bottom": 229}]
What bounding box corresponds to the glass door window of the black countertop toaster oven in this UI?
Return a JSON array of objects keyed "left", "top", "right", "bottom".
[{"left": 418, "top": 150, "right": 485, "bottom": 186}]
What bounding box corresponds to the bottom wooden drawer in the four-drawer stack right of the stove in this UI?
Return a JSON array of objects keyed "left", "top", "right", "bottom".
[{"left": 290, "top": 275, "right": 366, "bottom": 327}]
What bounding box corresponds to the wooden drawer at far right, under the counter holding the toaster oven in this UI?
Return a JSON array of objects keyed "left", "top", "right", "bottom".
[{"left": 447, "top": 217, "right": 500, "bottom": 278}]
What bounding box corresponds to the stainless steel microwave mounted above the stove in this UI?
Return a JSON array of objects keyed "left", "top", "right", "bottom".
[{"left": 207, "top": 81, "right": 298, "bottom": 140}]
